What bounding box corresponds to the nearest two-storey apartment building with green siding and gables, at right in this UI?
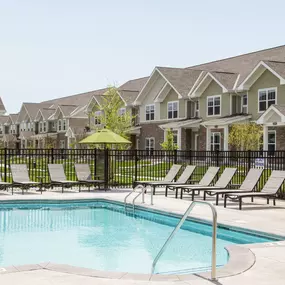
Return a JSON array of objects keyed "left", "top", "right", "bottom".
[{"left": 134, "top": 46, "right": 285, "bottom": 150}]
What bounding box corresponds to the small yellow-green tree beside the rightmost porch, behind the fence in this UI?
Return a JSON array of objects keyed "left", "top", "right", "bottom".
[{"left": 229, "top": 123, "right": 262, "bottom": 150}]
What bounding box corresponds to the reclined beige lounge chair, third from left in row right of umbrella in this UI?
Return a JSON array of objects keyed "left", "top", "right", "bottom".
[{"left": 171, "top": 166, "right": 220, "bottom": 199}]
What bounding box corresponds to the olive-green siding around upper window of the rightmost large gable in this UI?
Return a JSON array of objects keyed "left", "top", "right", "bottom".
[{"left": 248, "top": 70, "right": 285, "bottom": 120}]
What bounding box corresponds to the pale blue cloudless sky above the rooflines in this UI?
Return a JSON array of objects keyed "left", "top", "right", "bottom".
[{"left": 0, "top": 0, "right": 285, "bottom": 113}]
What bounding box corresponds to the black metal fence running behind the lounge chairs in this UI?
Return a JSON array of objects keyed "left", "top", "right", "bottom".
[{"left": 0, "top": 149, "right": 285, "bottom": 198}]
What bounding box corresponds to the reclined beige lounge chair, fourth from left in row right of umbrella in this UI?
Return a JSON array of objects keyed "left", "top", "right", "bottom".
[{"left": 178, "top": 167, "right": 237, "bottom": 201}]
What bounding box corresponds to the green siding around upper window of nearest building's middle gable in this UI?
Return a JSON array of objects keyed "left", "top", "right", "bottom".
[{"left": 199, "top": 81, "right": 231, "bottom": 120}]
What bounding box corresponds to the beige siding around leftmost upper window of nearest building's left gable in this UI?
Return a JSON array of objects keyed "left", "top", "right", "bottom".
[{"left": 140, "top": 76, "right": 165, "bottom": 122}]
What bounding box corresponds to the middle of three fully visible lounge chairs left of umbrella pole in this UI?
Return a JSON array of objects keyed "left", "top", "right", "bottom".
[{"left": 48, "top": 164, "right": 78, "bottom": 193}]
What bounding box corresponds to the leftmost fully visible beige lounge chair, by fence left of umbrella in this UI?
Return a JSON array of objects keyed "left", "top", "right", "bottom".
[{"left": 10, "top": 164, "right": 43, "bottom": 195}]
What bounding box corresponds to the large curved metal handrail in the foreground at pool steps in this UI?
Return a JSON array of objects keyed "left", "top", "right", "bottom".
[{"left": 151, "top": 201, "right": 217, "bottom": 281}]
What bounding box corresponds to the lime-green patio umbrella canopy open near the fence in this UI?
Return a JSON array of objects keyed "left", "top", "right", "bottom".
[{"left": 79, "top": 129, "right": 131, "bottom": 144}]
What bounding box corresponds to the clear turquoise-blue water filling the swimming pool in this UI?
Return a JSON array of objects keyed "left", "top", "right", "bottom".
[{"left": 0, "top": 200, "right": 278, "bottom": 274}]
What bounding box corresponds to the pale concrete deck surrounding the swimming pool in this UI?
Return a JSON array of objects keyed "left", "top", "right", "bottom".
[{"left": 0, "top": 186, "right": 285, "bottom": 285}]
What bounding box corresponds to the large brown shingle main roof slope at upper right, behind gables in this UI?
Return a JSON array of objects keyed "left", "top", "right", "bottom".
[{"left": 188, "top": 45, "right": 285, "bottom": 85}]
